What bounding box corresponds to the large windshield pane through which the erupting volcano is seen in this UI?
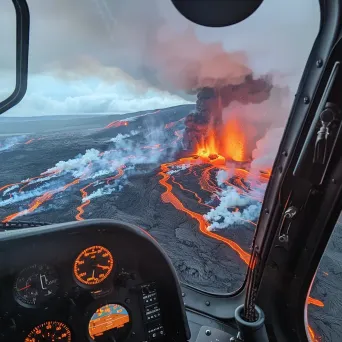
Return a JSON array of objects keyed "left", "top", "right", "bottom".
[{"left": 0, "top": 0, "right": 320, "bottom": 293}]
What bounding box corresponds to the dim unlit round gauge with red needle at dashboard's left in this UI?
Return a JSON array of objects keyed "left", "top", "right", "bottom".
[{"left": 14, "top": 264, "right": 59, "bottom": 307}]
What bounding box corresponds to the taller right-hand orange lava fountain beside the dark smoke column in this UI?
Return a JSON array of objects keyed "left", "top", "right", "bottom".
[{"left": 222, "top": 117, "right": 248, "bottom": 162}]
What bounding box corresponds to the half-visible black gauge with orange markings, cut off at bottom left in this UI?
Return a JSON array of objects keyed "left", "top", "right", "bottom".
[{"left": 25, "top": 321, "right": 71, "bottom": 342}]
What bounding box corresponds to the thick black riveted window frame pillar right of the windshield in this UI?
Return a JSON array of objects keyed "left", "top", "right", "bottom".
[{"left": 254, "top": 0, "right": 342, "bottom": 341}]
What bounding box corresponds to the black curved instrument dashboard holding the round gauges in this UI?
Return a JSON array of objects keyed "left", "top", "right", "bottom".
[{"left": 0, "top": 220, "right": 190, "bottom": 342}]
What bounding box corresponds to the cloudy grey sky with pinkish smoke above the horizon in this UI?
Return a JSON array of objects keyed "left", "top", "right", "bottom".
[{"left": 0, "top": 0, "right": 319, "bottom": 116}]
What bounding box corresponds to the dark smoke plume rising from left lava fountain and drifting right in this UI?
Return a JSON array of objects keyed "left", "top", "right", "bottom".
[{"left": 183, "top": 75, "right": 272, "bottom": 152}]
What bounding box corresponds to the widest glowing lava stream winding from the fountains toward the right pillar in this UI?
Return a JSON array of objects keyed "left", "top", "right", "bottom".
[{"left": 159, "top": 158, "right": 250, "bottom": 265}]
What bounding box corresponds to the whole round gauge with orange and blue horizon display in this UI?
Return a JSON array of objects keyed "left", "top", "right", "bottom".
[{"left": 88, "top": 304, "right": 131, "bottom": 341}]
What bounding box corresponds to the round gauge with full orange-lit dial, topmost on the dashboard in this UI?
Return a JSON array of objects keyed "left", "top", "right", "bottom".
[{"left": 74, "top": 246, "right": 114, "bottom": 285}]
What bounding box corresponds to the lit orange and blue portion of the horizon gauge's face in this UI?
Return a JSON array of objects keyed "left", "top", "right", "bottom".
[{"left": 88, "top": 304, "right": 130, "bottom": 340}]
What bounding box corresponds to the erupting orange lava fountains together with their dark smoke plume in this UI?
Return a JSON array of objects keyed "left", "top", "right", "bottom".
[{"left": 183, "top": 74, "right": 272, "bottom": 166}]
